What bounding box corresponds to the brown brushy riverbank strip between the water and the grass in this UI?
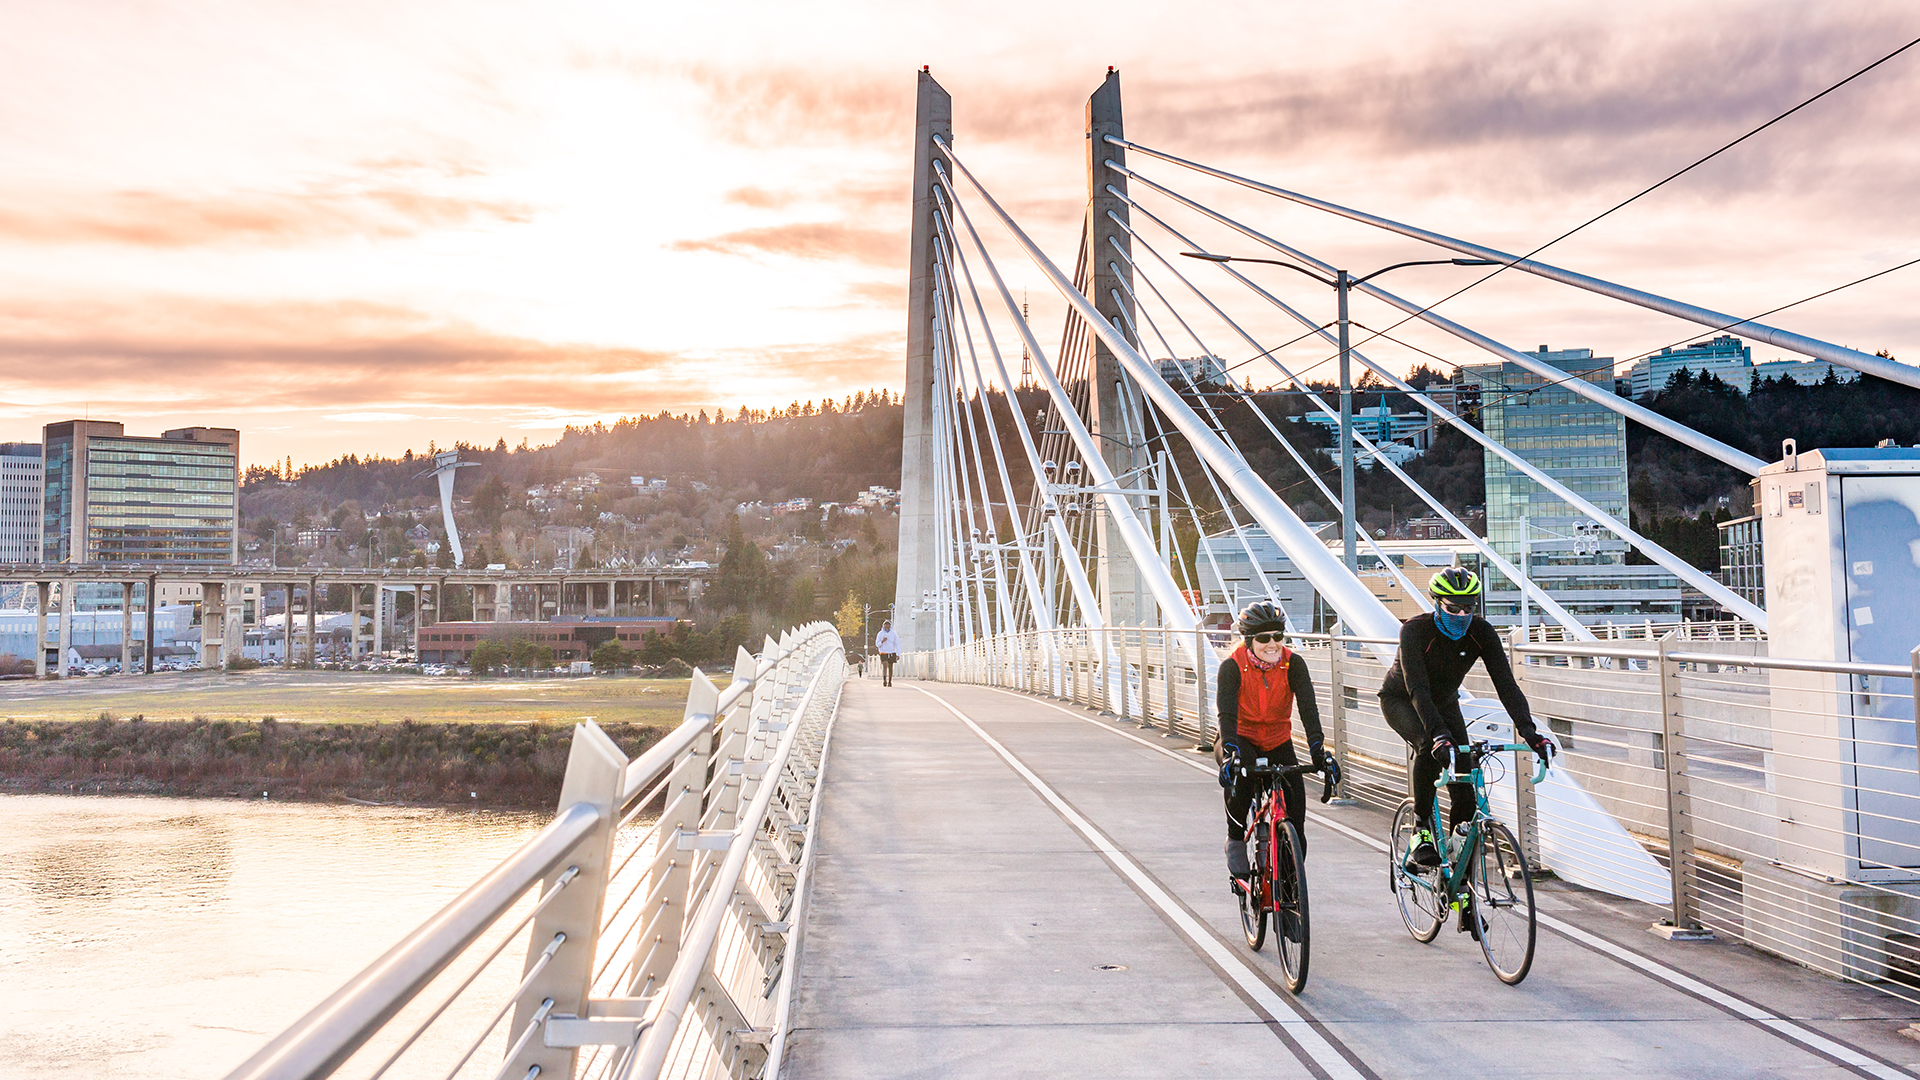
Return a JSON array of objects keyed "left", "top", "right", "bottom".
[{"left": 0, "top": 717, "right": 678, "bottom": 811}]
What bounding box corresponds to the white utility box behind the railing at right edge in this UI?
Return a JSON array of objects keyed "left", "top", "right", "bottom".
[{"left": 1755, "top": 440, "right": 1920, "bottom": 882}]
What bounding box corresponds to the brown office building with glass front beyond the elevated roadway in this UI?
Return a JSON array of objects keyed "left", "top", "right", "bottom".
[{"left": 42, "top": 421, "right": 240, "bottom": 565}]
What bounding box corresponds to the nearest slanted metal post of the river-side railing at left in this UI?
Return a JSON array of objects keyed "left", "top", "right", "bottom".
[{"left": 505, "top": 723, "right": 628, "bottom": 1076}]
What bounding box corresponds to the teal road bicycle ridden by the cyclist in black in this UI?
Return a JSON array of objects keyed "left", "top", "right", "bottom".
[{"left": 1386, "top": 742, "right": 1548, "bottom": 986}]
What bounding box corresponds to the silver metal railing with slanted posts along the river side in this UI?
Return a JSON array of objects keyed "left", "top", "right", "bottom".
[{"left": 228, "top": 623, "right": 845, "bottom": 1080}]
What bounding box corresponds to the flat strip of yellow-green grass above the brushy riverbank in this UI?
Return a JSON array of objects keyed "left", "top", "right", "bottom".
[{"left": 0, "top": 671, "right": 728, "bottom": 726}]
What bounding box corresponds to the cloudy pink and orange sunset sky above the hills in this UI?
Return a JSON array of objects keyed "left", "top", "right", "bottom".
[{"left": 0, "top": 0, "right": 1920, "bottom": 465}]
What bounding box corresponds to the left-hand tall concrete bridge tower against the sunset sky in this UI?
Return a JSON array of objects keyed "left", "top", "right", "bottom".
[{"left": 893, "top": 71, "right": 954, "bottom": 653}]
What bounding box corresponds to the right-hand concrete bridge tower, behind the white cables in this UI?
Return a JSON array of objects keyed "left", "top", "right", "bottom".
[{"left": 1087, "top": 67, "right": 1158, "bottom": 626}]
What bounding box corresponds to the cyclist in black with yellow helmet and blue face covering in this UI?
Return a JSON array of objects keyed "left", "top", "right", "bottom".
[{"left": 1380, "top": 567, "right": 1553, "bottom": 867}]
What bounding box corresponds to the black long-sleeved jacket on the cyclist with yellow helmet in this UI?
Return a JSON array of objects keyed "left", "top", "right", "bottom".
[{"left": 1380, "top": 611, "right": 1536, "bottom": 746}]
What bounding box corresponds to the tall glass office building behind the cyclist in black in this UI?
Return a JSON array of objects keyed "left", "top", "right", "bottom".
[{"left": 1461, "top": 346, "right": 1680, "bottom": 625}]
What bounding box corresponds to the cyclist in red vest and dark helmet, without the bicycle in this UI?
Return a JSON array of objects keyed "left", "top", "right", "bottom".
[{"left": 1215, "top": 600, "right": 1338, "bottom": 878}]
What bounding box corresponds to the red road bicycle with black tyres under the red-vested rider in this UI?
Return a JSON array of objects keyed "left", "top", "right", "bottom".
[{"left": 1233, "top": 757, "right": 1332, "bottom": 994}]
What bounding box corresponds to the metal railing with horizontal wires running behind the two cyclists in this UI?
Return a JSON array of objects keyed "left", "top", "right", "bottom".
[{"left": 902, "top": 623, "right": 1920, "bottom": 1003}]
